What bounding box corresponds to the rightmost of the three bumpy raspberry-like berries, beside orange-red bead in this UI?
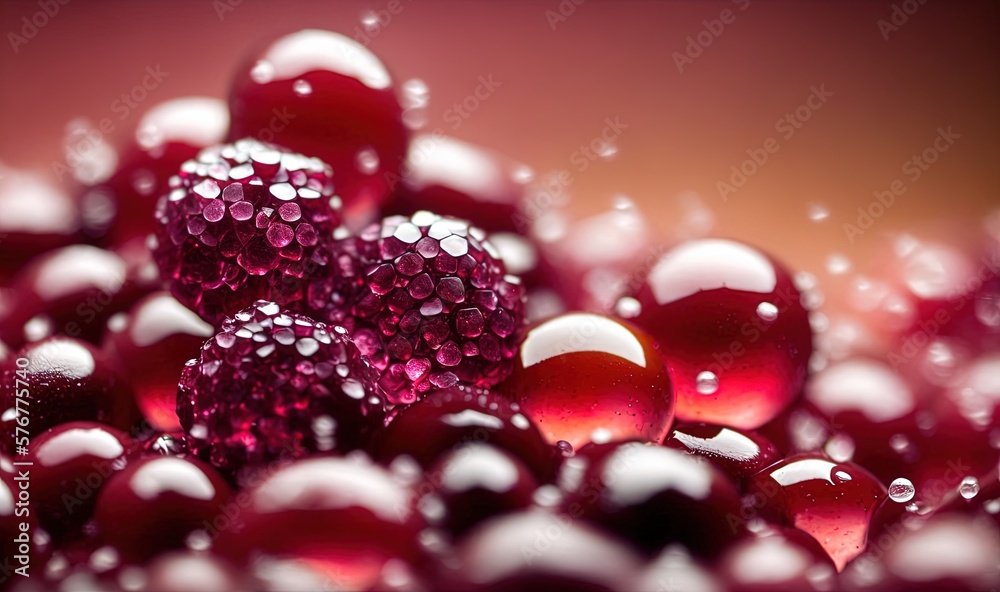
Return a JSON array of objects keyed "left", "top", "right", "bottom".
[{"left": 309, "top": 212, "right": 524, "bottom": 404}]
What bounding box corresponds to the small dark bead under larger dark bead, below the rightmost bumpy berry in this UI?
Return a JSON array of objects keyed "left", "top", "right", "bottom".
[{"left": 417, "top": 442, "right": 538, "bottom": 537}]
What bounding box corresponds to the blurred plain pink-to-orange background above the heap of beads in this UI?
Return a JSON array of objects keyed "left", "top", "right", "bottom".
[{"left": 0, "top": 0, "right": 1000, "bottom": 284}]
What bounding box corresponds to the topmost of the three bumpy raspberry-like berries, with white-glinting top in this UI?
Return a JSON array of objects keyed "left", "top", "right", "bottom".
[{"left": 153, "top": 139, "right": 341, "bottom": 326}]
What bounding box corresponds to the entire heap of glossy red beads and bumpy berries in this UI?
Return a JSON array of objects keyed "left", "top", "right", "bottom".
[{"left": 0, "top": 30, "right": 1000, "bottom": 592}]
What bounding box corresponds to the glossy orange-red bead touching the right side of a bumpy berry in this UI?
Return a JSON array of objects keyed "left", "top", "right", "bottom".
[{"left": 497, "top": 313, "right": 674, "bottom": 448}]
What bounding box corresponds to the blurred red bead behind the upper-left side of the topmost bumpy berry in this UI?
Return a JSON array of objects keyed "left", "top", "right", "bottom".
[{"left": 83, "top": 97, "right": 229, "bottom": 244}]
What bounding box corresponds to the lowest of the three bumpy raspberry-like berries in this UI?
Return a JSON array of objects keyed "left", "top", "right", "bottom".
[{"left": 177, "top": 301, "right": 384, "bottom": 472}]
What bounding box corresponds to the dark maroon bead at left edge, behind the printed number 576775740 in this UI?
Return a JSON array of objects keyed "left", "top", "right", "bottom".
[{"left": 0, "top": 337, "right": 140, "bottom": 448}]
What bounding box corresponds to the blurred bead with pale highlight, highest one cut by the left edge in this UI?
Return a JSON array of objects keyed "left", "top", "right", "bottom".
[{"left": 0, "top": 164, "right": 82, "bottom": 280}]
